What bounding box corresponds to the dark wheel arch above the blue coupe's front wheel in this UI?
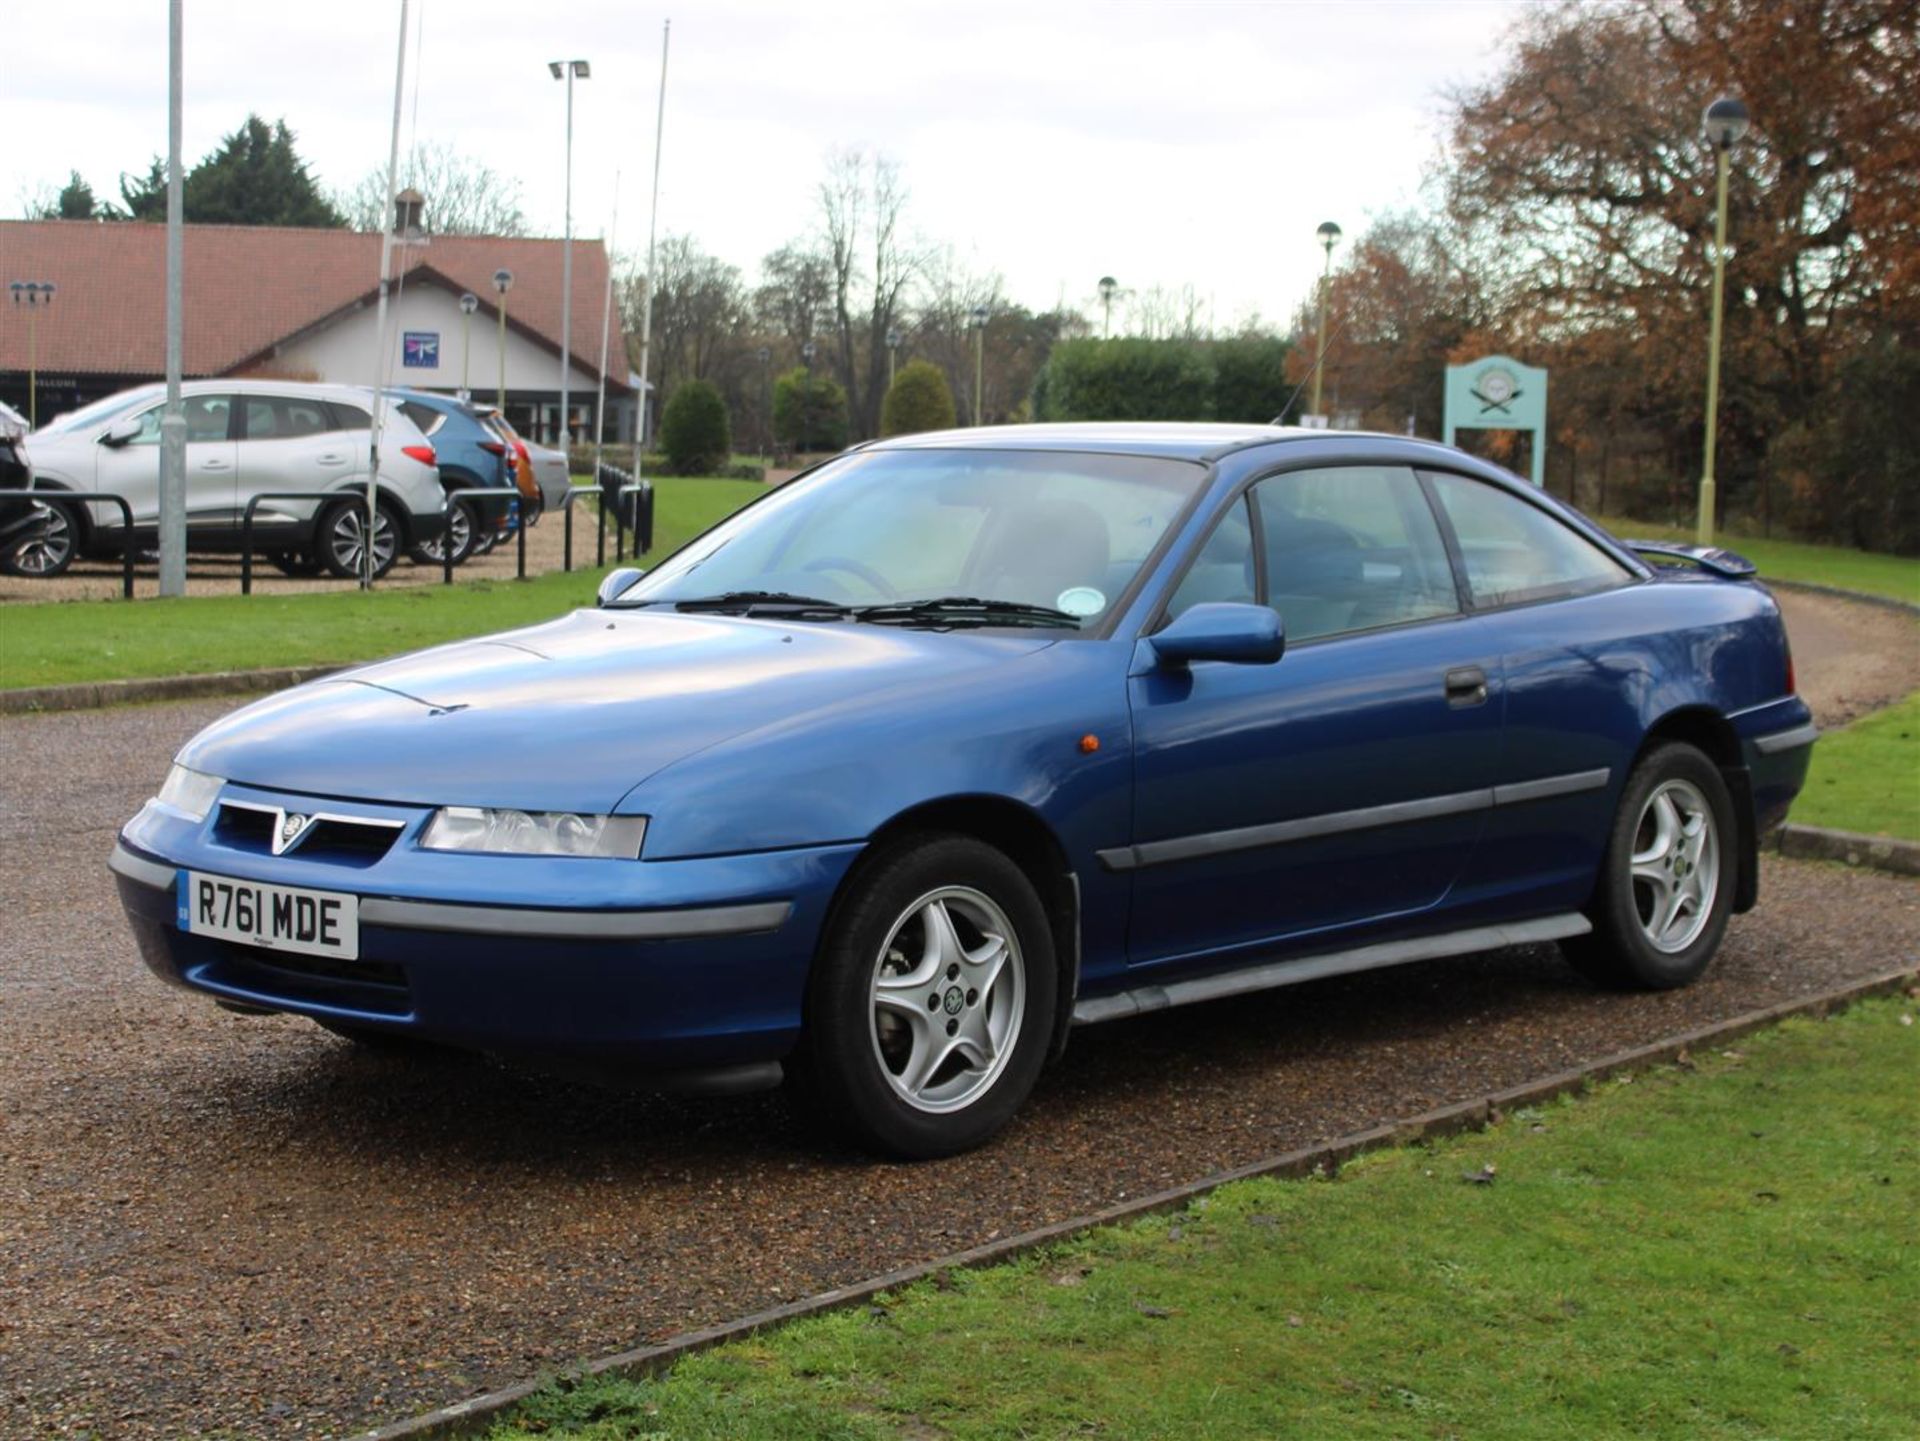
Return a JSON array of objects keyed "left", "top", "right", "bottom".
[{"left": 820, "top": 794, "right": 1081, "bottom": 1057}]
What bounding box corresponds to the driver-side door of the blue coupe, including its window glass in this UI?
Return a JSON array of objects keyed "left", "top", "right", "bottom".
[{"left": 1125, "top": 466, "right": 1503, "bottom": 973}]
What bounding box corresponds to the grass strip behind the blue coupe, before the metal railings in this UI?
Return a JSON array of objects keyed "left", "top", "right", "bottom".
[{"left": 0, "top": 480, "right": 766, "bottom": 689}]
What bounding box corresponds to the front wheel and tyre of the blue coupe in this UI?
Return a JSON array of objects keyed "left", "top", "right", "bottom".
[{"left": 801, "top": 835, "right": 1058, "bottom": 1159}]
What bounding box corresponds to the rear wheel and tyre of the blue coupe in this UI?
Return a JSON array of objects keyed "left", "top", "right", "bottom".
[{"left": 1561, "top": 741, "right": 1740, "bottom": 990}]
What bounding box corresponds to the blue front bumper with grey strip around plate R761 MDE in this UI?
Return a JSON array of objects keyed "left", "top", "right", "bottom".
[{"left": 109, "top": 787, "right": 858, "bottom": 1071}]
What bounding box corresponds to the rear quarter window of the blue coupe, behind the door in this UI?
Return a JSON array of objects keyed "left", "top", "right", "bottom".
[{"left": 1430, "top": 474, "right": 1632, "bottom": 606}]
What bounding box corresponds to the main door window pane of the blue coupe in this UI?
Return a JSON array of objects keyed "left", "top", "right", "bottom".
[{"left": 1254, "top": 466, "right": 1459, "bottom": 643}]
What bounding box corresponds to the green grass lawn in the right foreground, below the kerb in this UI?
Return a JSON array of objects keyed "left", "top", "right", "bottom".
[{"left": 490, "top": 1000, "right": 1920, "bottom": 1441}]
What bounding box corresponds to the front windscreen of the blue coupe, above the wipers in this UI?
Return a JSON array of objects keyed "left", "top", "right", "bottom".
[{"left": 622, "top": 449, "right": 1208, "bottom": 629}]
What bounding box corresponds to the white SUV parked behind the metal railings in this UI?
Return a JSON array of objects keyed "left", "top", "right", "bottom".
[{"left": 31, "top": 389, "right": 447, "bottom": 578}]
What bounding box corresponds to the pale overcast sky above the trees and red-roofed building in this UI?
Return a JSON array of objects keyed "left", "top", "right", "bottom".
[{"left": 0, "top": 0, "right": 1524, "bottom": 326}]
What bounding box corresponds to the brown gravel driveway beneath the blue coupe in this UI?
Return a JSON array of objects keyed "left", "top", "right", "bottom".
[{"left": 0, "top": 654, "right": 1920, "bottom": 1437}]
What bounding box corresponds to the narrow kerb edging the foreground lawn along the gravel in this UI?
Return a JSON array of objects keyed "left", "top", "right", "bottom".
[{"left": 355, "top": 967, "right": 1920, "bottom": 1441}]
